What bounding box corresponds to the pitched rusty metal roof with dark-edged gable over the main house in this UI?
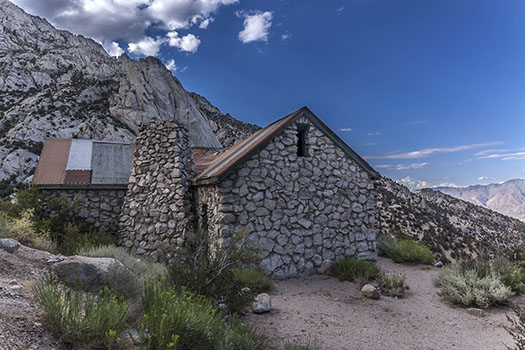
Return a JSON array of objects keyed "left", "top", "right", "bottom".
[{"left": 195, "top": 106, "right": 381, "bottom": 185}]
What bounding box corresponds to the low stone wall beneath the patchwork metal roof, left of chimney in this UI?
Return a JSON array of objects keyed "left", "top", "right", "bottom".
[{"left": 42, "top": 189, "right": 126, "bottom": 233}]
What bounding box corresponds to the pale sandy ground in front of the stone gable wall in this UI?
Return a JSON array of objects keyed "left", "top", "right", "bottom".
[{"left": 247, "top": 258, "right": 522, "bottom": 350}]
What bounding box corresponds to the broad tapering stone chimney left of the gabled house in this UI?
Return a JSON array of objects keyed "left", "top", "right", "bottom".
[{"left": 120, "top": 121, "right": 195, "bottom": 259}]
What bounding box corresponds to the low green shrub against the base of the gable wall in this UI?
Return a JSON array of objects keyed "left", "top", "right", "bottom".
[{"left": 330, "top": 256, "right": 381, "bottom": 284}]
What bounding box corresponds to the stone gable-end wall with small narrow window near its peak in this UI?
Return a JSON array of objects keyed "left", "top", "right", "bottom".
[{"left": 196, "top": 117, "right": 377, "bottom": 278}]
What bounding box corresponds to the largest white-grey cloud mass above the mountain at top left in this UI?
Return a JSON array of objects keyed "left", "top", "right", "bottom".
[{"left": 11, "top": 0, "right": 238, "bottom": 53}]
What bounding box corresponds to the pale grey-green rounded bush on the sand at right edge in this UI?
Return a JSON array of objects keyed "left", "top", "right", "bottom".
[{"left": 434, "top": 262, "right": 513, "bottom": 308}]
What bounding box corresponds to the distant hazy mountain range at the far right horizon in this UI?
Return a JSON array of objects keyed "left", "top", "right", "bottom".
[{"left": 435, "top": 179, "right": 525, "bottom": 221}]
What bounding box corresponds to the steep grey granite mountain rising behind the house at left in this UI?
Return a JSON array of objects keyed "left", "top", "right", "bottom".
[{"left": 0, "top": 0, "right": 258, "bottom": 186}]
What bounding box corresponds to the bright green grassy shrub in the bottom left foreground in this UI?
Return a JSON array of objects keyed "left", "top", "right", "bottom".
[{"left": 33, "top": 275, "right": 128, "bottom": 345}]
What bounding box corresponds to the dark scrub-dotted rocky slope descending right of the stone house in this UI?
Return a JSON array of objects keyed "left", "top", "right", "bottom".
[{"left": 377, "top": 178, "right": 525, "bottom": 261}]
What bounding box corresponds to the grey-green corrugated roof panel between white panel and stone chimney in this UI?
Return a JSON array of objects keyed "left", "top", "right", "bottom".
[{"left": 91, "top": 141, "right": 133, "bottom": 184}]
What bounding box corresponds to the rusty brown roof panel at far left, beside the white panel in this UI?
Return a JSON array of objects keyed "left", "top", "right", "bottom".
[{"left": 32, "top": 137, "right": 71, "bottom": 185}]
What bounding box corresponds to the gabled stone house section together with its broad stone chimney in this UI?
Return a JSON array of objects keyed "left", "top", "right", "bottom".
[{"left": 34, "top": 107, "right": 380, "bottom": 278}]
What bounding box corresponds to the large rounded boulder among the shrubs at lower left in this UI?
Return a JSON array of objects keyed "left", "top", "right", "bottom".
[{"left": 53, "top": 255, "right": 138, "bottom": 291}]
